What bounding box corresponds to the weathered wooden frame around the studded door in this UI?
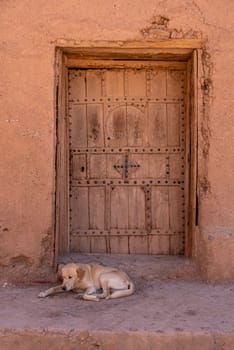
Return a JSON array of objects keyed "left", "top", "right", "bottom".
[{"left": 54, "top": 39, "right": 202, "bottom": 265}]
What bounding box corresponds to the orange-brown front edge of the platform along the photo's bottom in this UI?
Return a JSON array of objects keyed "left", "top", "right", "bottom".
[{"left": 0, "top": 330, "right": 234, "bottom": 350}]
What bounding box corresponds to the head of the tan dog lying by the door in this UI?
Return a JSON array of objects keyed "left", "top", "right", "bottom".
[{"left": 58, "top": 263, "right": 85, "bottom": 291}]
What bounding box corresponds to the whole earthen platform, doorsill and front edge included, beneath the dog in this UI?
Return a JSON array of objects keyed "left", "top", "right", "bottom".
[{"left": 0, "top": 254, "right": 234, "bottom": 350}]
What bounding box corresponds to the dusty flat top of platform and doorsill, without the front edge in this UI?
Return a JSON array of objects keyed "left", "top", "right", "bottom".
[{"left": 0, "top": 255, "right": 234, "bottom": 349}]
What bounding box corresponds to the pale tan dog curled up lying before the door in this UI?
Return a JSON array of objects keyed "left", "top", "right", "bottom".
[{"left": 38, "top": 263, "right": 135, "bottom": 301}]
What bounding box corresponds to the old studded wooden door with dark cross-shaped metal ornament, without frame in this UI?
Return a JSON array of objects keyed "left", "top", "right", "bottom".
[{"left": 68, "top": 66, "right": 186, "bottom": 254}]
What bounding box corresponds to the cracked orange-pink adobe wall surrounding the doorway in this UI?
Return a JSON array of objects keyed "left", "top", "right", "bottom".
[{"left": 0, "top": 0, "right": 234, "bottom": 279}]
